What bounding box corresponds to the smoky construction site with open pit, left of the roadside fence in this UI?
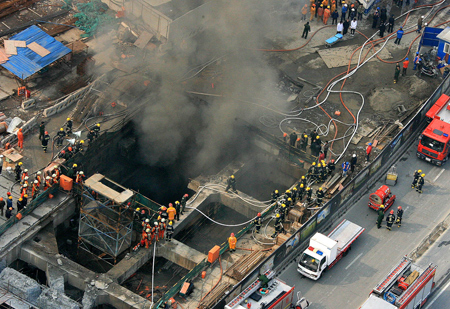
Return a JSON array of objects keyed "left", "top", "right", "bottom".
[{"left": 0, "top": 0, "right": 450, "bottom": 309}]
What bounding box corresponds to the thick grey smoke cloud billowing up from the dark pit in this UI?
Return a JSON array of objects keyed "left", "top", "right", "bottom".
[{"left": 134, "top": 1, "right": 288, "bottom": 172}]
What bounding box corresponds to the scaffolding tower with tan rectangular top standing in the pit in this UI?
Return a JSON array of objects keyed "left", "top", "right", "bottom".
[{"left": 78, "top": 174, "right": 134, "bottom": 265}]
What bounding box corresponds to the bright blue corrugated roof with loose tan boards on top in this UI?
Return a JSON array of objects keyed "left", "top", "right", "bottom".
[{"left": 2, "top": 26, "right": 70, "bottom": 79}]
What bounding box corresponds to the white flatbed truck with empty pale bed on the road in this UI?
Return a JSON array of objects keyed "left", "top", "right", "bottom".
[{"left": 297, "top": 219, "right": 364, "bottom": 280}]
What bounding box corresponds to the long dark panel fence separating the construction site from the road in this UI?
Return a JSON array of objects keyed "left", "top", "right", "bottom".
[{"left": 214, "top": 77, "right": 450, "bottom": 309}]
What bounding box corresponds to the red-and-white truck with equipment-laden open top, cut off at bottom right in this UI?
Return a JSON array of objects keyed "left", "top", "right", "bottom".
[{"left": 360, "top": 257, "right": 437, "bottom": 309}]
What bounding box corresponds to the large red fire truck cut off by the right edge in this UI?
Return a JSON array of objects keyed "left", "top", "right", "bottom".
[{"left": 417, "top": 94, "right": 450, "bottom": 166}]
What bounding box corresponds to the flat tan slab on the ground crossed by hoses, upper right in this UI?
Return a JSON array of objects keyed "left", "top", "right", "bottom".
[{"left": 318, "top": 45, "right": 392, "bottom": 69}]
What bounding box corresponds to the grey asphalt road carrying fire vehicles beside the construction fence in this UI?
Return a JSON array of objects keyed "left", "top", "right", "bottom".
[{"left": 279, "top": 142, "right": 450, "bottom": 309}]
